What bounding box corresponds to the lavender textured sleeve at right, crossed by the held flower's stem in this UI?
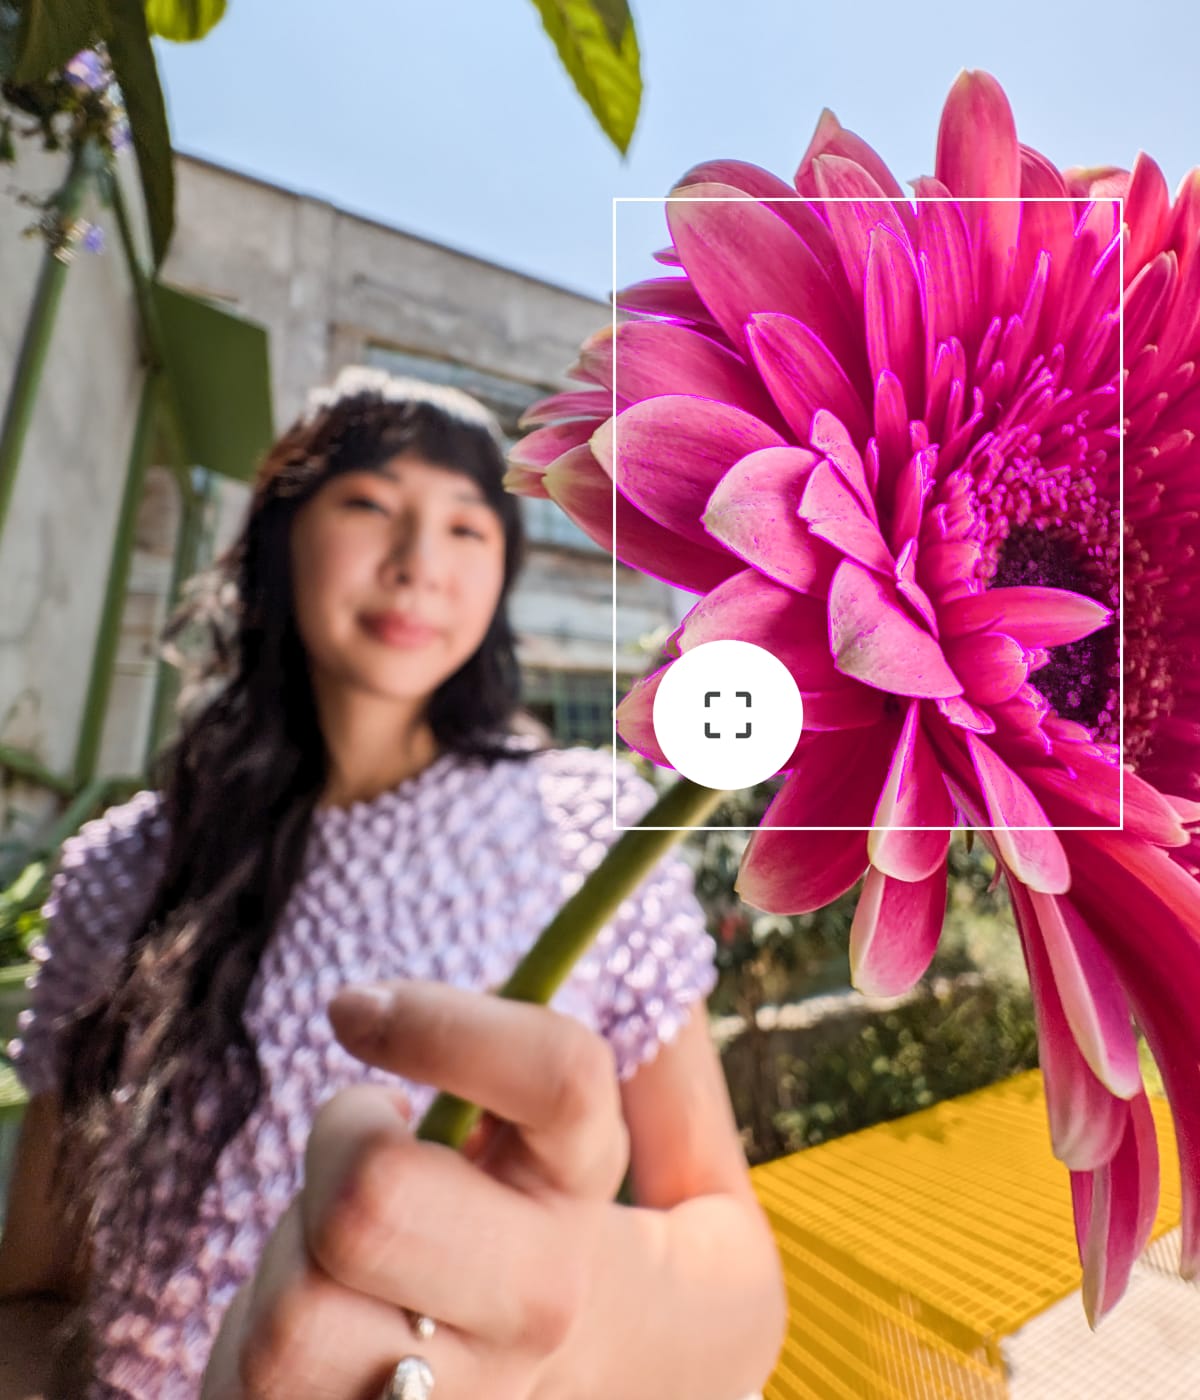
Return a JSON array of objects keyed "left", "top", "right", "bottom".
[{"left": 537, "top": 748, "right": 717, "bottom": 1079}]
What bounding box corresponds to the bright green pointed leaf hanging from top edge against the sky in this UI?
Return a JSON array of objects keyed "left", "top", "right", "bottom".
[{"left": 523, "top": 0, "right": 641, "bottom": 155}]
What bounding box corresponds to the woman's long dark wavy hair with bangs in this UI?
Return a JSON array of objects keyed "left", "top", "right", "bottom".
[{"left": 56, "top": 370, "right": 549, "bottom": 1277}]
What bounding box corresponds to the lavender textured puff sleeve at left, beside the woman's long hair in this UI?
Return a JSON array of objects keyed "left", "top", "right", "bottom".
[{"left": 7, "top": 791, "right": 167, "bottom": 1096}]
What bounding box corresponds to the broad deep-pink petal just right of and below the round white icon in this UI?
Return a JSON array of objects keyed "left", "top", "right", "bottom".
[{"left": 734, "top": 724, "right": 895, "bottom": 914}]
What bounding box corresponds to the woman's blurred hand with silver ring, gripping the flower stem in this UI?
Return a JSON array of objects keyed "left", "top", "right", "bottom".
[{"left": 202, "top": 981, "right": 629, "bottom": 1400}]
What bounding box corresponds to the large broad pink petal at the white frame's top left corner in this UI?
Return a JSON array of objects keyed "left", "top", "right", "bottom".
[{"left": 667, "top": 183, "right": 864, "bottom": 381}]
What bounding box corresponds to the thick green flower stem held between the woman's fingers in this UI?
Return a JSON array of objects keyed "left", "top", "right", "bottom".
[{"left": 417, "top": 778, "right": 728, "bottom": 1148}]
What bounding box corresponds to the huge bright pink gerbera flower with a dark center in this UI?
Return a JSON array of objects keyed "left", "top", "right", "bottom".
[{"left": 508, "top": 73, "right": 1200, "bottom": 1319}]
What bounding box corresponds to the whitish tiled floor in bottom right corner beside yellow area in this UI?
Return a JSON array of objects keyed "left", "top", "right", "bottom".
[{"left": 1003, "top": 1232, "right": 1200, "bottom": 1400}]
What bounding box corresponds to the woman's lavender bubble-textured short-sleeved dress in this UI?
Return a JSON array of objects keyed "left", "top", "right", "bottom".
[{"left": 8, "top": 748, "right": 716, "bottom": 1400}]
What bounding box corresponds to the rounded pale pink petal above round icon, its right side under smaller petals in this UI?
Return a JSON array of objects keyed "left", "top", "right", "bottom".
[{"left": 703, "top": 447, "right": 837, "bottom": 598}]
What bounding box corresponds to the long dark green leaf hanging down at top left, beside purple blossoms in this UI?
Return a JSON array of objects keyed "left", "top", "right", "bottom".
[{"left": 106, "top": 0, "right": 175, "bottom": 266}]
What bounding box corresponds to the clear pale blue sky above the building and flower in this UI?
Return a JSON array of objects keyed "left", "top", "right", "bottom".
[{"left": 160, "top": 0, "right": 1200, "bottom": 298}]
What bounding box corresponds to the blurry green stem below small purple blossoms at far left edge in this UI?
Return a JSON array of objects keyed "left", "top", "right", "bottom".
[{"left": 0, "top": 141, "right": 95, "bottom": 546}]
